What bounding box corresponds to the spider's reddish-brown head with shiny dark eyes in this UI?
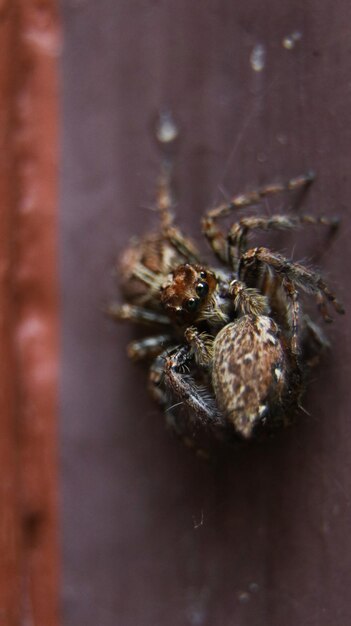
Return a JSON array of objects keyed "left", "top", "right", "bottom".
[{"left": 161, "top": 263, "right": 217, "bottom": 324}]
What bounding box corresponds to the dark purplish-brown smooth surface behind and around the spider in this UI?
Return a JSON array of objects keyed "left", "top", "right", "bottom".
[{"left": 60, "top": 0, "right": 351, "bottom": 626}]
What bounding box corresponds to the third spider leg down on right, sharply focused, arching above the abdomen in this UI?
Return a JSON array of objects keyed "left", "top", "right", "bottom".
[{"left": 239, "top": 247, "right": 344, "bottom": 321}]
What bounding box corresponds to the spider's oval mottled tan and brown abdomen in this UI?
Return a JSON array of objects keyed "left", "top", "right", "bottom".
[{"left": 212, "top": 315, "right": 289, "bottom": 438}]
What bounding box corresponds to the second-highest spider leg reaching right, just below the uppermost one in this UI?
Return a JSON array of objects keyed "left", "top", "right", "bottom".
[{"left": 228, "top": 215, "right": 339, "bottom": 264}]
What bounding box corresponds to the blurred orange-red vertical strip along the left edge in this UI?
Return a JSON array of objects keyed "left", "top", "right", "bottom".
[{"left": 0, "top": 0, "right": 59, "bottom": 626}]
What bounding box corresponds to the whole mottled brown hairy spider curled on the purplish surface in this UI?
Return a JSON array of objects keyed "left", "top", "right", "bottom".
[{"left": 109, "top": 154, "right": 344, "bottom": 442}]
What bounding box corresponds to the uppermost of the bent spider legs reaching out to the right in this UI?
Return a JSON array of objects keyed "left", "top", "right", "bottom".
[{"left": 202, "top": 172, "right": 314, "bottom": 263}]
